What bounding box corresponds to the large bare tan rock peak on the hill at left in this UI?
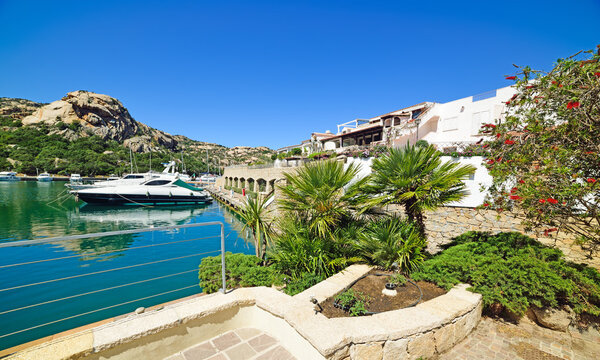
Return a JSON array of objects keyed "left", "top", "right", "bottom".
[{"left": 22, "top": 90, "right": 177, "bottom": 152}]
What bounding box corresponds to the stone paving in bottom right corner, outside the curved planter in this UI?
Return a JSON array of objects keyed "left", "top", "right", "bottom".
[{"left": 439, "top": 317, "right": 600, "bottom": 360}]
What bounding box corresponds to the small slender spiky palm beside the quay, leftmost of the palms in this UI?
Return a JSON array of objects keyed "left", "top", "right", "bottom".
[{"left": 238, "top": 196, "right": 272, "bottom": 261}]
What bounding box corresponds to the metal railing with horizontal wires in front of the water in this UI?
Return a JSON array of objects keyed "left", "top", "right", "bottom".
[{"left": 0, "top": 221, "right": 227, "bottom": 350}]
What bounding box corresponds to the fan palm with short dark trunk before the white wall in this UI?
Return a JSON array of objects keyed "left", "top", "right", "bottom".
[{"left": 365, "top": 145, "right": 476, "bottom": 237}]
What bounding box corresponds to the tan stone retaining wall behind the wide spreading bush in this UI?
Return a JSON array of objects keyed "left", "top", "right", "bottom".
[{"left": 425, "top": 207, "right": 600, "bottom": 269}]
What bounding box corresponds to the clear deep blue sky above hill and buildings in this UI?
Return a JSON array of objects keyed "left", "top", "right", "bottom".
[{"left": 0, "top": 0, "right": 600, "bottom": 148}]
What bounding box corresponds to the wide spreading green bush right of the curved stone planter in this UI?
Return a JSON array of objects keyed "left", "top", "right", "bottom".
[{"left": 412, "top": 232, "right": 600, "bottom": 316}]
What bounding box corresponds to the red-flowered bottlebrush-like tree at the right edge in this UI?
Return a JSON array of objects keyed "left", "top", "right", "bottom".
[{"left": 483, "top": 47, "right": 600, "bottom": 255}]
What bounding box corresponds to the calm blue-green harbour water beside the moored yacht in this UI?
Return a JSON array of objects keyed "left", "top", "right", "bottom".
[{"left": 0, "top": 181, "right": 254, "bottom": 349}]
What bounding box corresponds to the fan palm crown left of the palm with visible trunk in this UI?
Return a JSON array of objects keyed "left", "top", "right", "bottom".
[{"left": 279, "top": 160, "right": 366, "bottom": 238}]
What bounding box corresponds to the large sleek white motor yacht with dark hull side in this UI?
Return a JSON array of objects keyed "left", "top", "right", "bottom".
[{"left": 71, "top": 176, "right": 212, "bottom": 205}]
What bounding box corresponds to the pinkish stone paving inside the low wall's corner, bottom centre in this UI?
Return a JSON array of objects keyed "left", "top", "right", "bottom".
[{"left": 165, "top": 328, "right": 296, "bottom": 360}]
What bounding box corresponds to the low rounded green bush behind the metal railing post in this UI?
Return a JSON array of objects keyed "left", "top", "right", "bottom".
[{"left": 198, "top": 252, "right": 281, "bottom": 294}]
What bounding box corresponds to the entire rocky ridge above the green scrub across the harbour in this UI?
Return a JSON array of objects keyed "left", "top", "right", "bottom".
[{"left": 0, "top": 90, "right": 274, "bottom": 175}]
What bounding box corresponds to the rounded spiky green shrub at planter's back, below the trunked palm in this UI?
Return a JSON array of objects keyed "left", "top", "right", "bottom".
[{"left": 355, "top": 218, "right": 425, "bottom": 273}]
